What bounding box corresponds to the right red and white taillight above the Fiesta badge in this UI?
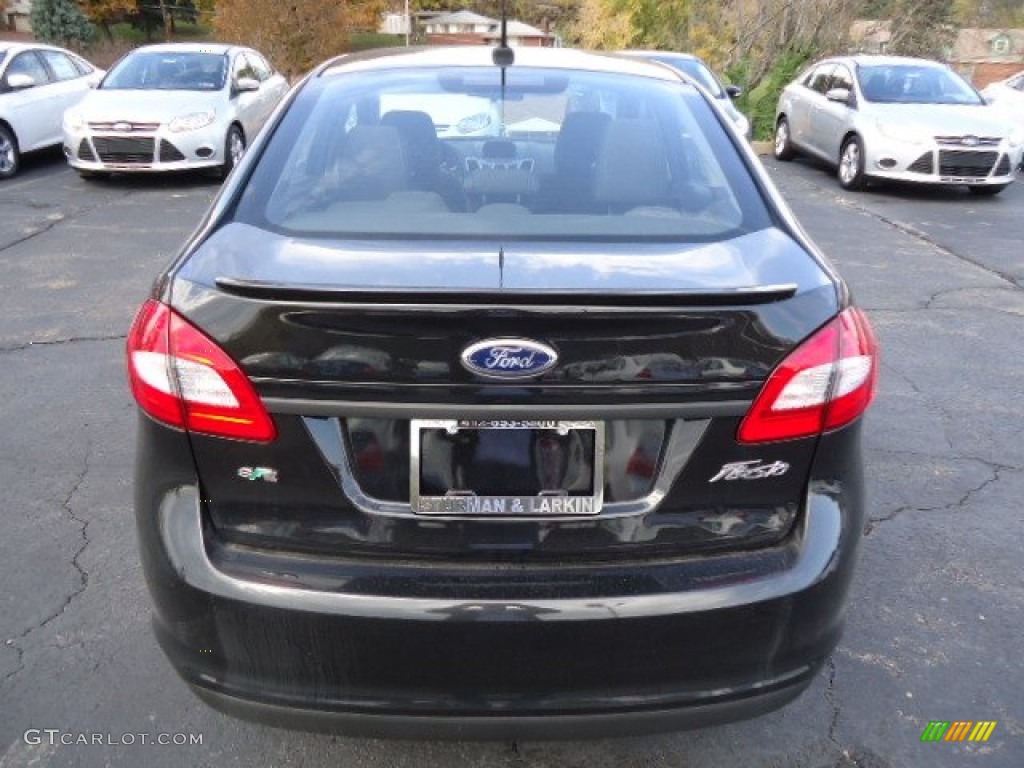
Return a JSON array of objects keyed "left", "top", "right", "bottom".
[{"left": 736, "top": 307, "right": 879, "bottom": 442}]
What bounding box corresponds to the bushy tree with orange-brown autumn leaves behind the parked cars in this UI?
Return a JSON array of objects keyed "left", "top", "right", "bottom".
[{"left": 213, "top": 0, "right": 384, "bottom": 76}]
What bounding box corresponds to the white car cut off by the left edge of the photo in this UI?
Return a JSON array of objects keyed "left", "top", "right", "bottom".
[{"left": 0, "top": 41, "right": 103, "bottom": 179}]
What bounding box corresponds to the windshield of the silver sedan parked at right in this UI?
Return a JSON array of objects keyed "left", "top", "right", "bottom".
[{"left": 857, "top": 65, "right": 984, "bottom": 104}]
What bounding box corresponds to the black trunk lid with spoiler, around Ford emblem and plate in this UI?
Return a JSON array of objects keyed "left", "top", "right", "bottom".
[{"left": 171, "top": 223, "right": 838, "bottom": 560}]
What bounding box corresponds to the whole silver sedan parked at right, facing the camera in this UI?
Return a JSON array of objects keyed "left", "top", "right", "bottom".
[{"left": 774, "top": 55, "right": 1024, "bottom": 195}]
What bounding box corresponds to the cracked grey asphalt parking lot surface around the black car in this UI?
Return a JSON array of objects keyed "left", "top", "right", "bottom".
[{"left": 0, "top": 156, "right": 1024, "bottom": 768}]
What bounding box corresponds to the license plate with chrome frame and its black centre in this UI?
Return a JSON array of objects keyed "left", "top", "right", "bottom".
[{"left": 409, "top": 419, "right": 604, "bottom": 517}]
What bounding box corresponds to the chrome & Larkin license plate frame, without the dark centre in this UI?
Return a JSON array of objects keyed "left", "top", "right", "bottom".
[{"left": 409, "top": 419, "right": 604, "bottom": 519}]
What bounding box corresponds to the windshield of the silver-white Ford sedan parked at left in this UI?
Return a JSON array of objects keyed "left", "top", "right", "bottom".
[{"left": 100, "top": 51, "right": 227, "bottom": 91}]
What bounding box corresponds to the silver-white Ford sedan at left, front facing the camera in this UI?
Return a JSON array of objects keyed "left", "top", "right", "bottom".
[{"left": 63, "top": 43, "right": 288, "bottom": 178}]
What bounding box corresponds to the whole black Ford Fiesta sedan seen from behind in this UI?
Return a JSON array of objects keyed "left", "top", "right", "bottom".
[{"left": 128, "top": 47, "right": 878, "bottom": 738}]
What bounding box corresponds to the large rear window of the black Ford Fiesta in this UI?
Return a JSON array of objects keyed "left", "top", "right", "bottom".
[{"left": 236, "top": 68, "right": 769, "bottom": 241}]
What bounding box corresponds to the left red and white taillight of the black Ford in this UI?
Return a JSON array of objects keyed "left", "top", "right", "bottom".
[{"left": 127, "top": 300, "right": 278, "bottom": 442}]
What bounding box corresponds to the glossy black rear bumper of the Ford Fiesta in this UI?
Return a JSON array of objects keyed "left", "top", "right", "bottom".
[{"left": 136, "top": 425, "right": 862, "bottom": 739}]
